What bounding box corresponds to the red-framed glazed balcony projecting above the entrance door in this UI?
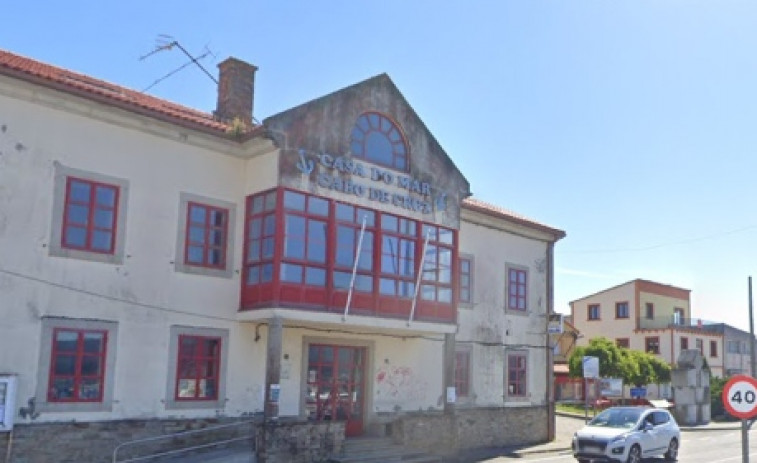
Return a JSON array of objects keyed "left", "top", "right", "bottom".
[{"left": 240, "top": 188, "right": 458, "bottom": 322}]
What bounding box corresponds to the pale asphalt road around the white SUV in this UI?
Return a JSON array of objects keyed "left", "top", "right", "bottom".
[{"left": 479, "top": 416, "right": 757, "bottom": 463}]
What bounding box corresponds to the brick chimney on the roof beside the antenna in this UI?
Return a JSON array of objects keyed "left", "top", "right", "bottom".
[{"left": 215, "top": 58, "right": 258, "bottom": 125}]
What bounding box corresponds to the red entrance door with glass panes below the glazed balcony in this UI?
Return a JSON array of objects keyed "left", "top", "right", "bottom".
[{"left": 307, "top": 344, "right": 365, "bottom": 436}]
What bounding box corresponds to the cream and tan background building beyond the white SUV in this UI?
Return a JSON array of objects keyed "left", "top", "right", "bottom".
[{"left": 570, "top": 279, "right": 724, "bottom": 396}]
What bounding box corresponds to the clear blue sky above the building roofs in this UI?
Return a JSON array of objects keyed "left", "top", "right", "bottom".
[{"left": 5, "top": 0, "right": 757, "bottom": 330}]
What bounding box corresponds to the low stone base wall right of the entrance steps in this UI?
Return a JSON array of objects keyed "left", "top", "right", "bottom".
[{"left": 391, "top": 406, "right": 549, "bottom": 454}]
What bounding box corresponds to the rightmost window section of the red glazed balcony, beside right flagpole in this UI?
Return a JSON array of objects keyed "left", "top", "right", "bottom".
[{"left": 421, "top": 224, "right": 455, "bottom": 304}]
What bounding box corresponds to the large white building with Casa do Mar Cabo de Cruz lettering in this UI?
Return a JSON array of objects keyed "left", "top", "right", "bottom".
[{"left": 0, "top": 51, "right": 565, "bottom": 463}]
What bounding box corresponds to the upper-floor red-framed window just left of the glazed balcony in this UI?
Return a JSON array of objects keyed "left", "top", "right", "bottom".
[{"left": 184, "top": 202, "right": 229, "bottom": 269}]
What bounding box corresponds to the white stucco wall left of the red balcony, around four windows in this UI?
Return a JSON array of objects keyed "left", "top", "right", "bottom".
[{"left": 0, "top": 81, "right": 265, "bottom": 421}]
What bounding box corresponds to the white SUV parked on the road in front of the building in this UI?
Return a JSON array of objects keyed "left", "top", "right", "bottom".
[{"left": 573, "top": 407, "right": 681, "bottom": 463}]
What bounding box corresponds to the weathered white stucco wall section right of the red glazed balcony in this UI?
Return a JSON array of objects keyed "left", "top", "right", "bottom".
[{"left": 456, "top": 212, "right": 547, "bottom": 406}]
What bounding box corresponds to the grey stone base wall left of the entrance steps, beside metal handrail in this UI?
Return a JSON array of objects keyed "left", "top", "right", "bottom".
[{"left": 0, "top": 418, "right": 344, "bottom": 463}]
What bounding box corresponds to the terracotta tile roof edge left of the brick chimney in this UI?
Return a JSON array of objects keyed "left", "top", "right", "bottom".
[{"left": 0, "top": 50, "right": 244, "bottom": 134}]
